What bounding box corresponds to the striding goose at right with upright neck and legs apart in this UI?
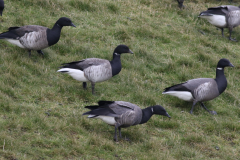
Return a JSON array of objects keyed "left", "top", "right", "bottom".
[{"left": 162, "top": 58, "right": 234, "bottom": 115}]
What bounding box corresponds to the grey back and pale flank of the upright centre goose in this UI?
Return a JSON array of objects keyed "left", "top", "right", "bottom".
[{"left": 80, "top": 58, "right": 112, "bottom": 82}]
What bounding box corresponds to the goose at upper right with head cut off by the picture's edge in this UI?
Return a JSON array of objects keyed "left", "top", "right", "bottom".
[{"left": 198, "top": 5, "right": 240, "bottom": 41}]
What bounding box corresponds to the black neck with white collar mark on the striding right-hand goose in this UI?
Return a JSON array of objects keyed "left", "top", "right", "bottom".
[{"left": 215, "top": 67, "right": 227, "bottom": 94}]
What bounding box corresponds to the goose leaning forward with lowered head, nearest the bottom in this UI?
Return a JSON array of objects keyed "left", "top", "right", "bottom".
[{"left": 83, "top": 101, "right": 171, "bottom": 141}]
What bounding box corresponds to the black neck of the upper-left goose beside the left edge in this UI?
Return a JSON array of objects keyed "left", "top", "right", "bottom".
[{"left": 47, "top": 23, "right": 62, "bottom": 46}]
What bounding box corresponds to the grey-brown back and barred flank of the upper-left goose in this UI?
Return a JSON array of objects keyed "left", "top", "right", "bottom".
[{"left": 15, "top": 25, "right": 48, "bottom": 50}]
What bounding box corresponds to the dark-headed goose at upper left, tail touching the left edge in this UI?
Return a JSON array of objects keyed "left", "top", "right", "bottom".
[{"left": 0, "top": 17, "right": 76, "bottom": 56}]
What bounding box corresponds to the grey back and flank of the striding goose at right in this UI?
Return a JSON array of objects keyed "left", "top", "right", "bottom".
[{"left": 183, "top": 78, "right": 219, "bottom": 102}]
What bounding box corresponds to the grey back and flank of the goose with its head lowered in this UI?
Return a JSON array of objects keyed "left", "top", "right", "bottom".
[{"left": 109, "top": 101, "right": 142, "bottom": 127}]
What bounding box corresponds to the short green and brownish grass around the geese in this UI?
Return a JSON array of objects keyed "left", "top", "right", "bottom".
[{"left": 0, "top": 0, "right": 240, "bottom": 160}]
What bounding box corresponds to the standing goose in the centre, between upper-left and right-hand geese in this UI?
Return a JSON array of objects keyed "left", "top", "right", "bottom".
[{"left": 57, "top": 45, "right": 133, "bottom": 94}]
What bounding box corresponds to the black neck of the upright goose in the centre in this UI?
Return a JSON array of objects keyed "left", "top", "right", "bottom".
[{"left": 110, "top": 53, "right": 122, "bottom": 76}]
